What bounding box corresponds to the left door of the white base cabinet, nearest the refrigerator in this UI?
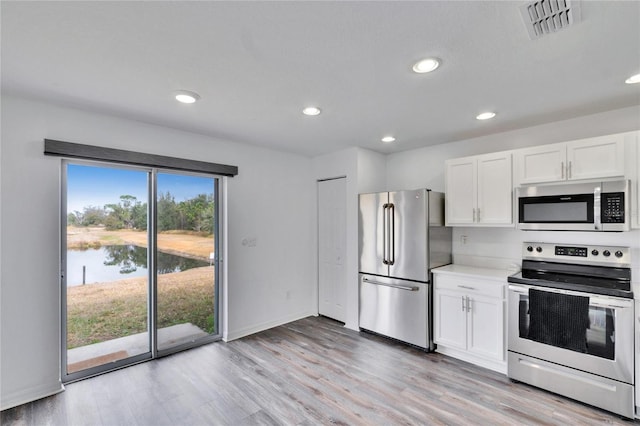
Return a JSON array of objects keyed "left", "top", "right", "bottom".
[{"left": 433, "top": 290, "right": 467, "bottom": 349}]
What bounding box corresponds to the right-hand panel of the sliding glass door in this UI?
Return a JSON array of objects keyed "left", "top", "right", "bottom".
[{"left": 156, "top": 173, "right": 218, "bottom": 352}]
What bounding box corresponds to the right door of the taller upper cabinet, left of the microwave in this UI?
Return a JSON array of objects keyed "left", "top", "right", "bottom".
[{"left": 476, "top": 153, "right": 513, "bottom": 225}]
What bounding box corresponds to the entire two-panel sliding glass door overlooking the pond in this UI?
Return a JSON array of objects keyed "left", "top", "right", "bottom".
[{"left": 61, "top": 162, "right": 219, "bottom": 381}]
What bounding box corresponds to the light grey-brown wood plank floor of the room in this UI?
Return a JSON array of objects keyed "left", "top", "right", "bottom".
[{"left": 2, "top": 317, "right": 633, "bottom": 425}]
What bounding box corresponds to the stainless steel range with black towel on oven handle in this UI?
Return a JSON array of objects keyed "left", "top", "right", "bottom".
[{"left": 507, "top": 243, "right": 634, "bottom": 418}]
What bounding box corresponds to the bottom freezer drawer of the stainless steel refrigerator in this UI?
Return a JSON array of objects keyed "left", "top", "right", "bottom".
[{"left": 359, "top": 274, "right": 431, "bottom": 349}]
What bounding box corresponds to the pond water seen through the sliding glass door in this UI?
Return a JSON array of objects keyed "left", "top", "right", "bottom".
[{"left": 67, "top": 245, "right": 209, "bottom": 287}]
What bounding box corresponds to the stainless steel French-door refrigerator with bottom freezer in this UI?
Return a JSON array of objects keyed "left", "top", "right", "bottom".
[{"left": 359, "top": 189, "right": 451, "bottom": 350}]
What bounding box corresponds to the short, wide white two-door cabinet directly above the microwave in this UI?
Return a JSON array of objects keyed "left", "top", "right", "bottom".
[{"left": 514, "top": 134, "right": 625, "bottom": 185}]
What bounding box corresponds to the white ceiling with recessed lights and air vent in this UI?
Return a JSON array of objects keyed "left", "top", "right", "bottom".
[{"left": 0, "top": 0, "right": 640, "bottom": 156}]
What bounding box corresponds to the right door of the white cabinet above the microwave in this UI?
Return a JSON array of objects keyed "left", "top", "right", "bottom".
[{"left": 567, "top": 135, "right": 624, "bottom": 180}]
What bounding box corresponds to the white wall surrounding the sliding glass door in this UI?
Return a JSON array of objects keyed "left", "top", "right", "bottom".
[{"left": 0, "top": 94, "right": 317, "bottom": 409}]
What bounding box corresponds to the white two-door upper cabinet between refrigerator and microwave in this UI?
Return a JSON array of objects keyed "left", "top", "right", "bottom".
[{"left": 445, "top": 151, "right": 513, "bottom": 226}]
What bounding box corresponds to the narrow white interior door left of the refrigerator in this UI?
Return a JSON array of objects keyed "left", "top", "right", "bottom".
[{"left": 318, "top": 178, "right": 347, "bottom": 322}]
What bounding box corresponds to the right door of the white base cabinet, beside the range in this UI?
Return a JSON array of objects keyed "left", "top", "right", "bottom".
[{"left": 467, "top": 295, "right": 504, "bottom": 361}]
